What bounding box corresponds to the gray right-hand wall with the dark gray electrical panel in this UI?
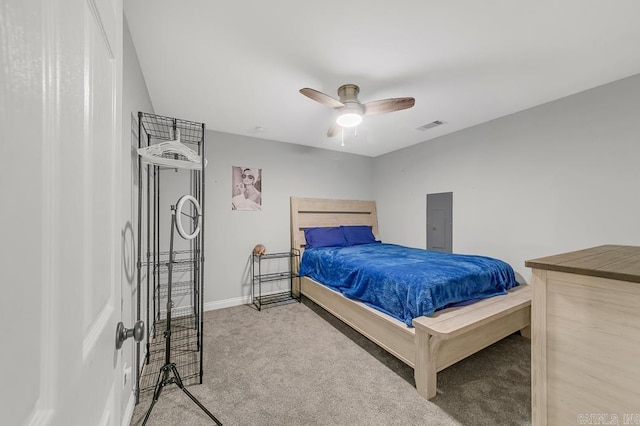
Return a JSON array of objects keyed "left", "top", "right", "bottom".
[{"left": 373, "top": 75, "right": 640, "bottom": 281}]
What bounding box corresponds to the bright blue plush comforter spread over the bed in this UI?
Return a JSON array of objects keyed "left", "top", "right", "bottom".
[{"left": 300, "top": 243, "right": 518, "bottom": 326}]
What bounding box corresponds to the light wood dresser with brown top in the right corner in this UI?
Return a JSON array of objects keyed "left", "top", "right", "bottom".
[{"left": 525, "top": 245, "right": 640, "bottom": 426}]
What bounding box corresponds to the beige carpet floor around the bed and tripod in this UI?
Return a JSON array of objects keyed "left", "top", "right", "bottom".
[{"left": 131, "top": 300, "right": 531, "bottom": 426}]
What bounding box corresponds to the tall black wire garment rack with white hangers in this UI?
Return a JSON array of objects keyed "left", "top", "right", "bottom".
[{"left": 136, "top": 112, "right": 206, "bottom": 402}]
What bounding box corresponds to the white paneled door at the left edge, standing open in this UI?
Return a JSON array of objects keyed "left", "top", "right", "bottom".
[{"left": 0, "top": 0, "right": 129, "bottom": 426}]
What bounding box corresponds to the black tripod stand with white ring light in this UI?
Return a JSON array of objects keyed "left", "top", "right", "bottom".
[{"left": 142, "top": 200, "right": 222, "bottom": 426}]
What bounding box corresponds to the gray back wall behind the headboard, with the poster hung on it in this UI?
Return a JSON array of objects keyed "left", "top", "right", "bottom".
[{"left": 198, "top": 132, "right": 373, "bottom": 309}]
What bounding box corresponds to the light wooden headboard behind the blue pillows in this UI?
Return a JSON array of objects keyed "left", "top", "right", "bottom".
[{"left": 291, "top": 197, "right": 380, "bottom": 253}]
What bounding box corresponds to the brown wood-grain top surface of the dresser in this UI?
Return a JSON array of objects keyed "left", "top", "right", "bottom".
[{"left": 524, "top": 245, "right": 640, "bottom": 283}]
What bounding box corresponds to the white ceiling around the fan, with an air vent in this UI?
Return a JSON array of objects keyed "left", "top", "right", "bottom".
[{"left": 124, "top": 0, "right": 640, "bottom": 157}]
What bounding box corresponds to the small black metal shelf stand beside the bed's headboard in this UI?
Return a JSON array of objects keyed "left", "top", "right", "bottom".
[{"left": 251, "top": 249, "right": 301, "bottom": 311}]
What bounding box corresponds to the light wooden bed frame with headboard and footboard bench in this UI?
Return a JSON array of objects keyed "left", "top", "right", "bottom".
[{"left": 291, "top": 197, "right": 531, "bottom": 399}]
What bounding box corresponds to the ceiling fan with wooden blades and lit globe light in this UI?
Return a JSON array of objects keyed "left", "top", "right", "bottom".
[{"left": 300, "top": 84, "right": 416, "bottom": 137}]
